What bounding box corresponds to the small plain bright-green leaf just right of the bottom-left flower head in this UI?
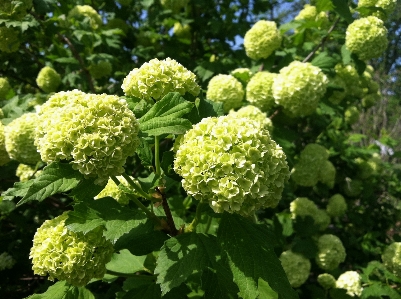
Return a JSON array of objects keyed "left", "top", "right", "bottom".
[{"left": 106, "top": 249, "right": 146, "bottom": 274}]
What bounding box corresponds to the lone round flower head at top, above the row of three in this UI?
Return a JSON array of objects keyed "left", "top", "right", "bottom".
[{"left": 244, "top": 20, "right": 282, "bottom": 60}]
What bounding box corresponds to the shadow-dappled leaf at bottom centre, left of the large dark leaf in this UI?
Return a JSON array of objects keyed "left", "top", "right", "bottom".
[{"left": 155, "top": 233, "right": 216, "bottom": 295}]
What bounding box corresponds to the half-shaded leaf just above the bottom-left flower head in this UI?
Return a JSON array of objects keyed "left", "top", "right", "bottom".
[{"left": 66, "top": 197, "right": 146, "bottom": 242}]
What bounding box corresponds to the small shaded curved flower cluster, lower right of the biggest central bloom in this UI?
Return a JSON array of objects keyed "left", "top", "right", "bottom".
[{"left": 290, "top": 197, "right": 330, "bottom": 231}]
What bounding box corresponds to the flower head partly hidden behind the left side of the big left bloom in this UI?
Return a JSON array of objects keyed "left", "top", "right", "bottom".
[{"left": 4, "top": 113, "right": 40, "bottom": 165}]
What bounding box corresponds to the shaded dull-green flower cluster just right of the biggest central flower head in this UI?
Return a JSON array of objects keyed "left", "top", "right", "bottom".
[{"left": 291, "top": 143, "right": 336, "bottom": 188}]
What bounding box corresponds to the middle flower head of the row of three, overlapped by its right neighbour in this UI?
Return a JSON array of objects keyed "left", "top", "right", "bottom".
[{"left": 246, "top": 72, "right": 277, "bottom": 112}]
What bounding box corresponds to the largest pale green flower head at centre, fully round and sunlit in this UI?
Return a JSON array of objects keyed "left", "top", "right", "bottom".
[{"left": 174, "top": 116, "right": 289, "bottom": 216}]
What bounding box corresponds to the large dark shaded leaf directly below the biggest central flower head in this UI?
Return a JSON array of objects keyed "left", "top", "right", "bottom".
[{"left": 217, "top": 213, "right": 298, "bottom": 299}]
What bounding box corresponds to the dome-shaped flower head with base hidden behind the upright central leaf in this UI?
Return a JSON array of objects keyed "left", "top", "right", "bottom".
[{"left": 121, "top": 58, "right": 200, "bottom": 101}]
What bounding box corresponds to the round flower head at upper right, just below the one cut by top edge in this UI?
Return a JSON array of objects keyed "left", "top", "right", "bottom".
[{"left": 345, "top": 16, "right": 388, "bottom": 60}]
